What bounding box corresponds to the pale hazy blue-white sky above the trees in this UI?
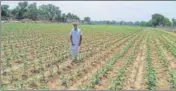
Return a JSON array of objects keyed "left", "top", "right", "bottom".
[{"left": 1, "top": 1, "right": 176, "bottom": 21}]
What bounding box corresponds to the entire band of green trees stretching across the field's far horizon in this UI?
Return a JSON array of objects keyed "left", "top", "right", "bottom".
[{"left": 1, "top": 1, "right": 176, "bottom": 27}]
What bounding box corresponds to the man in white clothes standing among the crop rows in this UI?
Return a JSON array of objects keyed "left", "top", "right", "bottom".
[{"left": 70, "top": 23, "right": 82, "bottom": 61}]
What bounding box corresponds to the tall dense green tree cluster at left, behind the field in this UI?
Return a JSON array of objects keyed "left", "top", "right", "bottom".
[{"left": 1, "top": 2, "right": 80, "bottom": 22}]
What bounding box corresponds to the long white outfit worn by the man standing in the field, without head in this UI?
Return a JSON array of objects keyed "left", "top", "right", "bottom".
[{"left": 70, "top": 29, "right": 82, "bottom": 58}]
